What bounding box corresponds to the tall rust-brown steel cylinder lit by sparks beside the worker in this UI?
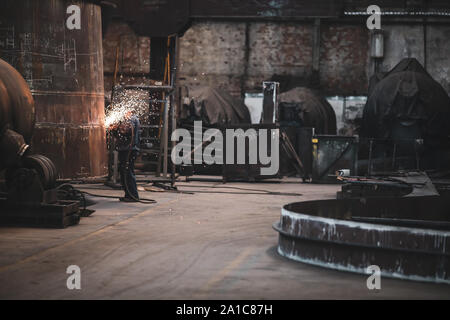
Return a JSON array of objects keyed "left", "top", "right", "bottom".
[{"left": 0, "top": 0, "right": 107, "bottom": 178}]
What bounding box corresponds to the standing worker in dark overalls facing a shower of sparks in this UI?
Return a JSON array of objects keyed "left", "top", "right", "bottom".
[{"left": 116, "top": 116, "right": 140, "bottom": 201}]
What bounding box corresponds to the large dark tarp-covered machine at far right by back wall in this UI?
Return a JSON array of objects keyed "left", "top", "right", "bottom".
[{"left": 359, "top": 58, "right": 450, "bottom": 174}]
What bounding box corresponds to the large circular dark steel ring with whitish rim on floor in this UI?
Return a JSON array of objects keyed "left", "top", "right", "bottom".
[{"left": 273, "top": 197, "right": 450, "bottom": 284}]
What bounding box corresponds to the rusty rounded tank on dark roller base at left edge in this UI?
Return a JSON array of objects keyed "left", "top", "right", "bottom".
[{"left": 0, "top": 59, "right": 80, "bottom": 227}]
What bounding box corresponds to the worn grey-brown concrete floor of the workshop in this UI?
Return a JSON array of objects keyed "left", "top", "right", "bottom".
[{"left": 0, "top": 179, "right": 450, "bottom": 299}]
